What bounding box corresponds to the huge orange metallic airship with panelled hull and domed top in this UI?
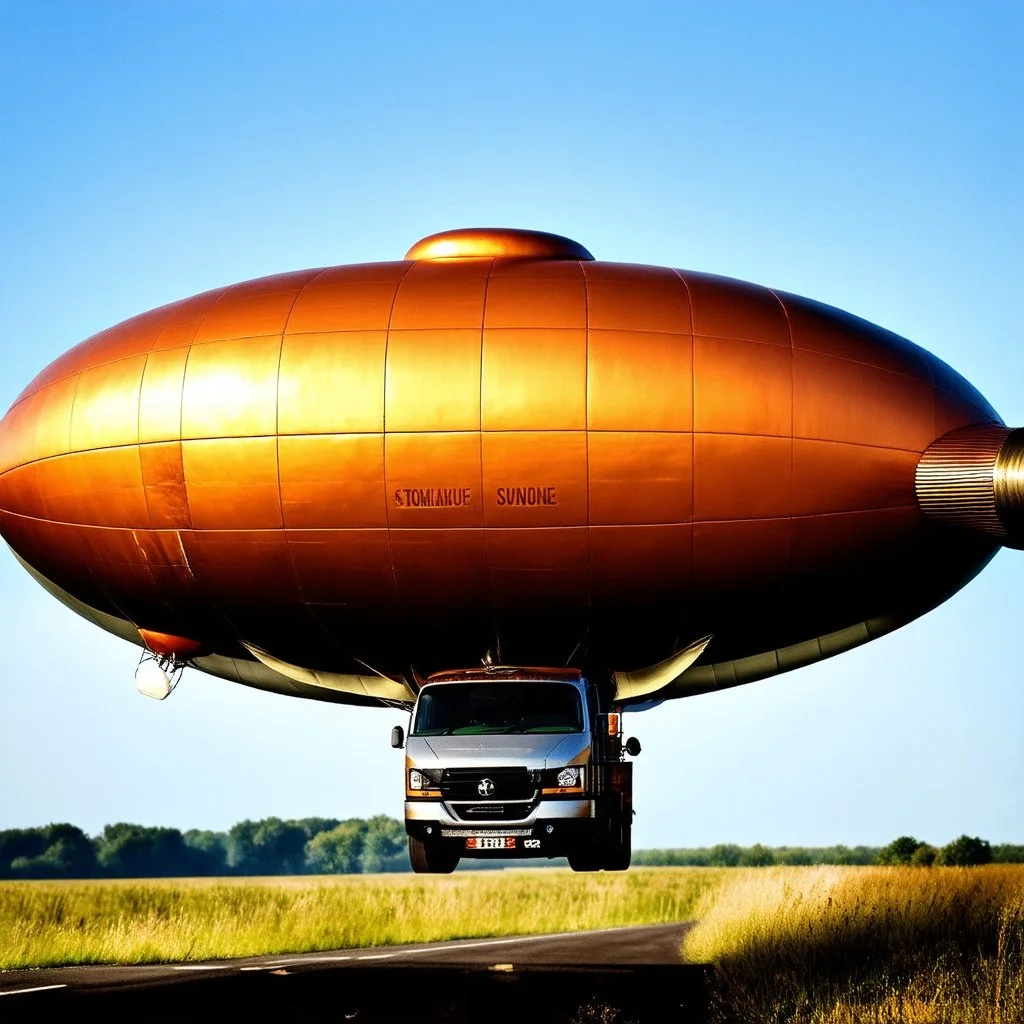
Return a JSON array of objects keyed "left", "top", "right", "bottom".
[{"left": 0, "top": 228, "right": 1024, "bottom": 705}]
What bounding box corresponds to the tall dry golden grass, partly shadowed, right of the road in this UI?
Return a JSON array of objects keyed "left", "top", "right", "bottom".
[{"left": 683, "top": 865, "right": 1024, "bottom": 1024}]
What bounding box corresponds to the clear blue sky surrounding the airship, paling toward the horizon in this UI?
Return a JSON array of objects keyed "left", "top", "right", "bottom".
[{"left": 0, "top": 0, "right": 1024, "bottom": 847}]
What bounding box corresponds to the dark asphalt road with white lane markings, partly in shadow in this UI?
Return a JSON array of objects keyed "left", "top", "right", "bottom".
[{"left": 0, "top": 924, "right": 705, "bottom": 1024}]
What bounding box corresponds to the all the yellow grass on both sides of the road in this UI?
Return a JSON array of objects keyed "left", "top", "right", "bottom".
[{"left": 9, "top": 865, "right": 1024, "bottom": 1024}]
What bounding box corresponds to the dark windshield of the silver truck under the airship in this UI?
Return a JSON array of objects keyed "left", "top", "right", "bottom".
[{"left": 413, "top": 682, "right": 583, "bottom": 736}]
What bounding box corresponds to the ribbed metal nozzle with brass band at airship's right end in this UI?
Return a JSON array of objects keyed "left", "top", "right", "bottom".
[{"left": 915, "top": 424, "right": 1024, "bottom": 549}]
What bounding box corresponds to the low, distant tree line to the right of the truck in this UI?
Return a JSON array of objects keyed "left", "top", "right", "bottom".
[{"left": 633, "top": 836, "right": 1024, "bottom": 867}]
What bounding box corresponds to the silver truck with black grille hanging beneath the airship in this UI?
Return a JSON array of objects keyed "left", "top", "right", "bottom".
[{"left": 392, "top": 669, "right": 640, "bottom": 872}]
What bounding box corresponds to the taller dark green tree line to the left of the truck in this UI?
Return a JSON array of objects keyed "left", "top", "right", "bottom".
[{"left": 0, "top": 814, "right": 410, "bottom": 879}]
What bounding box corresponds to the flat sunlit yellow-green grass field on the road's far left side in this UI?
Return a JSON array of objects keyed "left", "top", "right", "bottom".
[{"left": 0, "top": 868, "right": 721, "bottom": 970}]
